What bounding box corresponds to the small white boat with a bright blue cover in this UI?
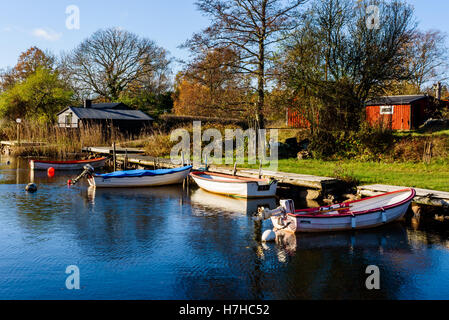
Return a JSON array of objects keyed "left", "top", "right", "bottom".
[{"left": 87, "top": 166, "right": 192, "bottom": 188}]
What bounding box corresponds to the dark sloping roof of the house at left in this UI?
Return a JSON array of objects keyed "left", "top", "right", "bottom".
[{"left": 59, "top": 107, "right": 154, "bottom": 121}]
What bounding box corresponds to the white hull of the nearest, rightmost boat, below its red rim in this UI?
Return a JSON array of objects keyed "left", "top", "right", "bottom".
[{"left": 271, "top": 189, "right": 415, "bottom": 232}]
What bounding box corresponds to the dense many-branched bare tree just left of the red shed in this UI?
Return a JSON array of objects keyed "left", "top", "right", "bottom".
[{"left": 279, "top": 0, "right": 415, "bottom": 131}]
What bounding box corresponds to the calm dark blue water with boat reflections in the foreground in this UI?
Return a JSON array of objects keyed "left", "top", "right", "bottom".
[{"left": 0, "top": 159, "right": 449, "bottom": 300}]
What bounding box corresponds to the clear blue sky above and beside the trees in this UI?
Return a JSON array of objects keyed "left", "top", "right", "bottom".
[{"left": 0, "top": 0, "right": 449, "bottom": 74}]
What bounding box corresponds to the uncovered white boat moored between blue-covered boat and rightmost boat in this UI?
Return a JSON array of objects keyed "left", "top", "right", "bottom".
[{"left": 190, "top": 171, "right": 277, "bottom": 198}]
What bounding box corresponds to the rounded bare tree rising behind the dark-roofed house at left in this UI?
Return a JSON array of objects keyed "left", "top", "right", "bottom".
[{"left": 61, "top": 28, "right": 170, "bottom": 101}]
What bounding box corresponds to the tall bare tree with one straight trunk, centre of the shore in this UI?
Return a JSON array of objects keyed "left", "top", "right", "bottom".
[{"left": 184, "top": 0, "right": 306, "bottom": 127}]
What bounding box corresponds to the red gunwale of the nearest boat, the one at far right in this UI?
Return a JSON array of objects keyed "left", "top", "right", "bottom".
[{"left": 288, "top": 188, "right": 416, "bottom": 218}]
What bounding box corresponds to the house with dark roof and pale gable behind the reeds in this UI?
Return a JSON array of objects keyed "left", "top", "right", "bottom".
[{"left": 57, "top": 100, "right": 154, "bottom": 131}]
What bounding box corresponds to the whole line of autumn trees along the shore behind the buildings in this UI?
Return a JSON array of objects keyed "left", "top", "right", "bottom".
[{"left": 0, "top": 0, "right": 447, "bottom": 134}]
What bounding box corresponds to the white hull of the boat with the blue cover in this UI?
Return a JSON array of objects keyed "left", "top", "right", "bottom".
[{"left": 87, "top": 169, "right": 190, "bottom": 188}]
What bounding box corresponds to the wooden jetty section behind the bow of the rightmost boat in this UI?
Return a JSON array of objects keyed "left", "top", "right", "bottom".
[{"left": 357, "top": 184, "right": 449, "bottom": 208}]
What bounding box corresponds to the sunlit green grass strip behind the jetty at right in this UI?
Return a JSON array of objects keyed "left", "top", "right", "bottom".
[{"left": 243, "top": 159, "right": 449, "bottom": 191}]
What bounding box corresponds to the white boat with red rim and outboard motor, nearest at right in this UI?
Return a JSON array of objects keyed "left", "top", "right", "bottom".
[{"left": 260, "top": 189, "right": 416, "bottom": 232}]
